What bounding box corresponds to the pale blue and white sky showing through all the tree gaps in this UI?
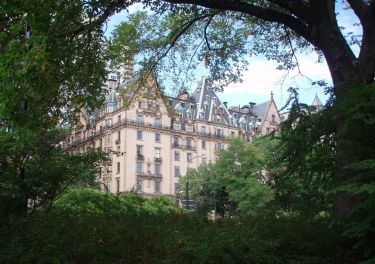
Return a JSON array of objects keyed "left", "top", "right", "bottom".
[{"left": 106, "top": 2, "right": 362, "bottom": 109}]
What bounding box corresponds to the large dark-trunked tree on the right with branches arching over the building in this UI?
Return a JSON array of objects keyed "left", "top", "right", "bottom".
[{"left": 108, "top": 0, "right": 375, "bottom": 217}]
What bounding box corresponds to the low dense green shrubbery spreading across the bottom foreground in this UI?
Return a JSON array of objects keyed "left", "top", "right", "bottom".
[{"left": 0, "top": 189, "right": 355, "bottom": 263}]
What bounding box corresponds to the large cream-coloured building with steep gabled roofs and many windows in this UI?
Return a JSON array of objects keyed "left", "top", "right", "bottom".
[{"left": 63, "top": 76, "right": 281, "bottom": 197}]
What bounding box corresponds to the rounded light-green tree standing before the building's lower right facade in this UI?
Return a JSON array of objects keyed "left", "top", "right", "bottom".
[{"left": 182, "top": 138, "right": 273, "bottom": 217}]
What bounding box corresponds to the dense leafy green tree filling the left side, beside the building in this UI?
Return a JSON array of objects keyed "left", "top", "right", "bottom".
[{"left": 0, "top": 0, "right": 135, "bottom": 219}]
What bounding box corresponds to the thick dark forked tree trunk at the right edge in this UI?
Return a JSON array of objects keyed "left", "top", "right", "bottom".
[{"left": 314, "top": 3, "right": 375, "bottom": 218}]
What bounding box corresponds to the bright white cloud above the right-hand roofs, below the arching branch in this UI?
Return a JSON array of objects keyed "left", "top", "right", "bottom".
[{"left": 221, "top": 54, "right": 331, "bottom": 105}]
